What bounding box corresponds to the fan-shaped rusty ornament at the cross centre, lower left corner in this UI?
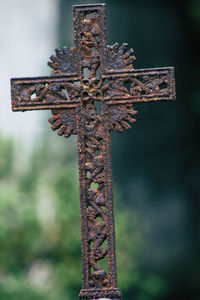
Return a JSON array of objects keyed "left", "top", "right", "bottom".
[{"left": 49, "top": 109, "right": 77, "bottom": 138}]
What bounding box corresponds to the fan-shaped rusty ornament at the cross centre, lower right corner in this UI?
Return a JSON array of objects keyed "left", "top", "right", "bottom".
[{"left": 109, "top": 104, "right": 137, "bottom": 132}]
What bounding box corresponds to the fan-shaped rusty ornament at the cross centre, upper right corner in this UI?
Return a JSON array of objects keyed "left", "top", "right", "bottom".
[{"left": 106, "top": 43, "right": 136, "bottom": 70}]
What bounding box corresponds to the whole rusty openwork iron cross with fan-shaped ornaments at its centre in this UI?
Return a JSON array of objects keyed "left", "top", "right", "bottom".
[{"left": 11, "top": 4, "right": 175, "bottom": 300}]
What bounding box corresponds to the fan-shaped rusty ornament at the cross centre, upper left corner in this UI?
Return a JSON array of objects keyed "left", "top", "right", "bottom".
[{"left": 48, "top": 46, "right": 77, "bottom": 74}]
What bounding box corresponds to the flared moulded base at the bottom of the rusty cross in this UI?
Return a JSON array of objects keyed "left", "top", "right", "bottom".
[{"left": 79, "top": 288, "right": 123, "bottom": 300}]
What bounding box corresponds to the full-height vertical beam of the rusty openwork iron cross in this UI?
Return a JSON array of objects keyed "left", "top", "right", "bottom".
[{"left": 74, "top": 5, "right": 121, "bottom": 299}]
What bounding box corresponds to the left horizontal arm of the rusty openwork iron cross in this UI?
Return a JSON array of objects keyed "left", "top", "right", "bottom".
[{"left": 11, "top": 75, "right": 80, "bottom": 111}]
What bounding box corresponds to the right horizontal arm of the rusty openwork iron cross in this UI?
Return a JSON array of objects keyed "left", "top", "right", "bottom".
[{"left": 103, "top": 67, "right": 175, "bottom": 104}]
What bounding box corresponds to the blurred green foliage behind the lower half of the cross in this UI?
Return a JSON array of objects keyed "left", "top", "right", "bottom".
[{"left": 0, "top": 134, "right": 166, "bottom": 300}]
